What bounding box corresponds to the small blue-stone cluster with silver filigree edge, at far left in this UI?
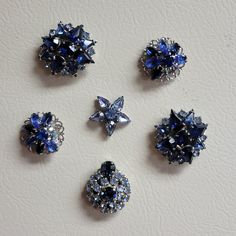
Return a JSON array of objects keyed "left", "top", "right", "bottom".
[{"left": 20, "top": 112, "right": 64, "bottom": 154}]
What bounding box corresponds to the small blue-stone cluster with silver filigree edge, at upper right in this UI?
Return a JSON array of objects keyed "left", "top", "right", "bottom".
[{"left": 141, "top": 38, "right": 187, "bottom": 81}]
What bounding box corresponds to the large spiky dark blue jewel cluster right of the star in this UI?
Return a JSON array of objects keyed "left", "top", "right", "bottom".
[{"left": 155, "top": 110, "right": 207, "bottom": 164}]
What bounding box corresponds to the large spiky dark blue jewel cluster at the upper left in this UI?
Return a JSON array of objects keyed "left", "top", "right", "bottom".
[{"left": 39, "top": 22, "right": 96, "bottom": 76}]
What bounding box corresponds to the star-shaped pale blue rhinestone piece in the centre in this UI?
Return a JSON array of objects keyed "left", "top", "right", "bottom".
[{"left": 89, "top": 96, "right": 130, "bottom": 136}]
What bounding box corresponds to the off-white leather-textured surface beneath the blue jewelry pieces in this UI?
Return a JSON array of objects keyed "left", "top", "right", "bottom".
[{"left": 0, "top": 0, "right": 236, "bottom": 236}]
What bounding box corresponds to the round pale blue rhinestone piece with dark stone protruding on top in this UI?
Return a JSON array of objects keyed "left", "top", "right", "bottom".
[{"left": 86, "top": 161, "right": 131, "bottom": 213}]
